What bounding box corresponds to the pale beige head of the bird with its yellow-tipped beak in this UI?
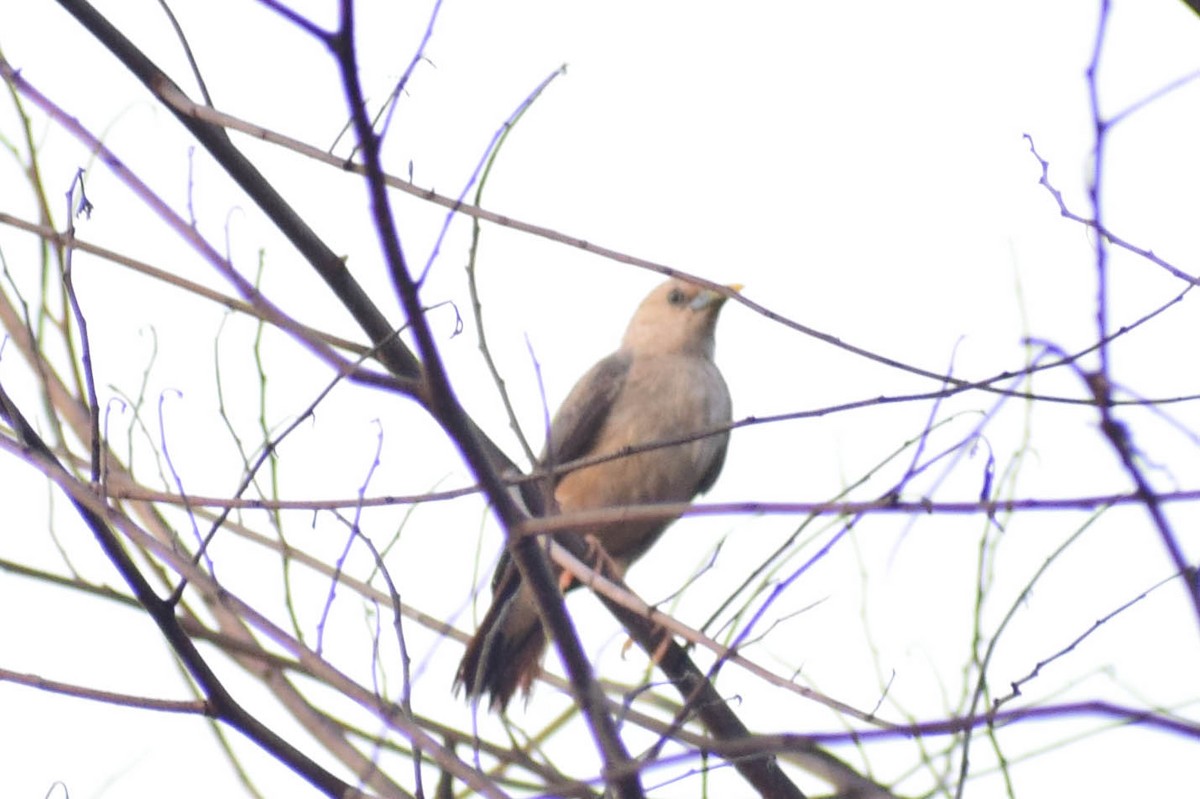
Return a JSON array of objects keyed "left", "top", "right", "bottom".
[{"left": 620, "top": 278, "right": 742, "bottom": 358}]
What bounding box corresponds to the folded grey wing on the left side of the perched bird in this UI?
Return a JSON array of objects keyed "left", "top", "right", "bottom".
[{"left": 541, "top": 353, "right": 631, "bottom": 465}]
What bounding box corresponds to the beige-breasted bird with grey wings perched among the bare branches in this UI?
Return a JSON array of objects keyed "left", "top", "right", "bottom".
[{"left": 455, "top": 280, "right": 740, "bottom": 710}]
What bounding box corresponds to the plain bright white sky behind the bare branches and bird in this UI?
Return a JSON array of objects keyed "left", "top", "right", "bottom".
[{"left": 0, "top": 0, "right": 1200, "bottom": 799}]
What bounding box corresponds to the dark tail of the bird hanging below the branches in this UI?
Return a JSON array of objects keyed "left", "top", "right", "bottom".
[{"left": 455, "top": 578, "right": 546, "bottom": 710}]
